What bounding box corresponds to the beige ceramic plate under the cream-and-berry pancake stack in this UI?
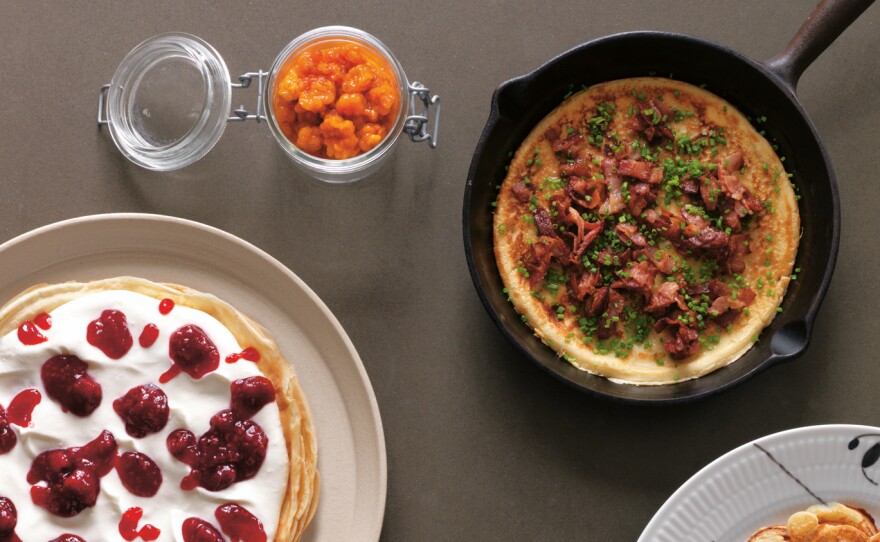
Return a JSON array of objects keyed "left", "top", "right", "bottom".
[{"left": 0, "top": 214, "right": 387, "bottom": 542}]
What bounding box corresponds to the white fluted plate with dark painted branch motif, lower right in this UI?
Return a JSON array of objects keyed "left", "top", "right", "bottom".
[{"left": 639, "top": 425, "right": 880, "bottom": 542}]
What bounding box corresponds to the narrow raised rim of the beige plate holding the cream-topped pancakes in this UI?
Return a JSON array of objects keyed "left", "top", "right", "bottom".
[{"left": 0, "top": 212, "right": 388, "bottom": 541}]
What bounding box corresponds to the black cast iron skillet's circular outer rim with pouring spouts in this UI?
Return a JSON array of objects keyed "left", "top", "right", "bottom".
[{"left": 462, "top": 30, "right": 841, "bottom": 405}]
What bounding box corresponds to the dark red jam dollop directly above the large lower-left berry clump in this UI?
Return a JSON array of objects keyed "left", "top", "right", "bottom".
[{"left": 40, "top": 354, "right": 102, "bottom": 416}]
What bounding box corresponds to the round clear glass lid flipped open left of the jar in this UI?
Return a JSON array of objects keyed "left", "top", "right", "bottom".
[{"left": 106, "top": 33, "right": 232, "bottom": 171}]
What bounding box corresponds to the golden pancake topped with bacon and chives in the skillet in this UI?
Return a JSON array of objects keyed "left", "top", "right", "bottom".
[{"left": 494, "top": 78, "right": 800, "bottom": 384}]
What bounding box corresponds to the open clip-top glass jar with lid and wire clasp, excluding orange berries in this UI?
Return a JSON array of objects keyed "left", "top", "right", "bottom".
[{"left": 98, "top": 26, "right": 440, "bottom": 183}]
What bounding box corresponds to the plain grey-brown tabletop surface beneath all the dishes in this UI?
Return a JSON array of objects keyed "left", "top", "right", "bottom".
[{"left": 0, "top": 0, "right": 880, "bottom": 541}]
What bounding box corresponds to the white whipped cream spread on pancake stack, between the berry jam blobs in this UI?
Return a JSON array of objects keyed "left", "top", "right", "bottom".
[{"left": 0, "top": 291, "right": 289, "bottom": 542}]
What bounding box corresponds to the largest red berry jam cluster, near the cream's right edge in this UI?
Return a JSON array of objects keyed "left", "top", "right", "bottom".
[{"left": 166, "top": 376, "right": 275, "bottom": 491}]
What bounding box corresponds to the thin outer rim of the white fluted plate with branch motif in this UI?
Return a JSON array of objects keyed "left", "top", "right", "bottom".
[{"left": 637, "top": 423, "right": 880, "bottom": 542}]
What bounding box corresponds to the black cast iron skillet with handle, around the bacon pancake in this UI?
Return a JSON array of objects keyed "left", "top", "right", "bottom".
[{"left": 463, "top": 0, "right": 873, "bottom": 403}]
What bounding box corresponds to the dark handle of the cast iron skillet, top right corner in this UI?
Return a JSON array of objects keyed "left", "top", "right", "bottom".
[{"left": 764, "top": 0, "right": 874, "bottom": 94}]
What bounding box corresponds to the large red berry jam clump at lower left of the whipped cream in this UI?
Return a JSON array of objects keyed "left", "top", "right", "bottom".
[{"left": 27, "top": 431, "right": 117, "bottom": 517}]
